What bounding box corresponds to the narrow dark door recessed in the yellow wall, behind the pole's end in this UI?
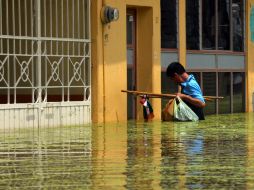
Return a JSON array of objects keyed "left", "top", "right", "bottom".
[{"left": 126, "top": 9, "right": 137, "bottom": 120}]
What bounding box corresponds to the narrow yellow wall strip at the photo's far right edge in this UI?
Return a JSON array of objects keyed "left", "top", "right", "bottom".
[{"left": 246, "top": 0, "right": 254, "bottom": 112}]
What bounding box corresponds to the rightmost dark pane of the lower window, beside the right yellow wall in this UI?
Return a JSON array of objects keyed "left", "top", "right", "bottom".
[{"left": 233, "top": 73, "right": 245, "bottom": 113}]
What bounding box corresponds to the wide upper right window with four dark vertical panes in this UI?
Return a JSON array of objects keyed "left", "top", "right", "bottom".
[{"left": 186, "top": 0, "right": 244, "bottom": 51}]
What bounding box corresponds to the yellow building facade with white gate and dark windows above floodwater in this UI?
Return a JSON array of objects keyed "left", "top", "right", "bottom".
[{"left": 0, "top": 0, "right": 254, "bottom": 127}]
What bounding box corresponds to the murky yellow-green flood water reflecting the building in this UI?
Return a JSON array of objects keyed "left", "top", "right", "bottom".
[{"left": 0, "top": 113, "right": 254, "bottom": 190}]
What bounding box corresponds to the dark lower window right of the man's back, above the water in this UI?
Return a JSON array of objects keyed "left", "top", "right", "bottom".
[{"left": 185, "top": 71, "right": 245, "bottom": 115}]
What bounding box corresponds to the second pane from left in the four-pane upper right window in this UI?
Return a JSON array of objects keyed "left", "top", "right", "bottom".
[{"left": 202, "top": 0, "right": 215, "bottom": 49}]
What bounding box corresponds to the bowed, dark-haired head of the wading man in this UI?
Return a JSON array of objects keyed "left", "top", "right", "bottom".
[{"left": 167, "top": 62, "right": 186, "bottom": 83}]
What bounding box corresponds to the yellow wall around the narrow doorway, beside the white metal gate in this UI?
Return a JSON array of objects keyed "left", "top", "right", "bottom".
[{"left": 91, "top": 0, "right": 161, "bottom": 122}]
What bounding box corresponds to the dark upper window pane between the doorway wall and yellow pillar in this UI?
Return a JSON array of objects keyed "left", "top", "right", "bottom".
[{"left": 161, "top": 0, "right": 177, "bottom": 48}]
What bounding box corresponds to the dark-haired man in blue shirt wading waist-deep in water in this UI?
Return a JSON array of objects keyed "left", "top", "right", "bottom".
[{"left": 167, "top": 62, "right": 205, "bottom": 120}]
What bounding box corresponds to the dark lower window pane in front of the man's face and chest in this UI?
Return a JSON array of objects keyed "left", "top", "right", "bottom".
[{"left": 161, "top": 72, "right": 178, "bottom": 108}]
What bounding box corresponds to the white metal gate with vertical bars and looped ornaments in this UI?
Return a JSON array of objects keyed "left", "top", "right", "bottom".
[{"left": 0, "top": 0, "right": 91, "bottom": 126}]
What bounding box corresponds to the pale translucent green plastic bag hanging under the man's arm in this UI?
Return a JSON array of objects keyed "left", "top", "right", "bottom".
[{"left": 174, "top": 97, "right": 199, "bottom": 121}]
